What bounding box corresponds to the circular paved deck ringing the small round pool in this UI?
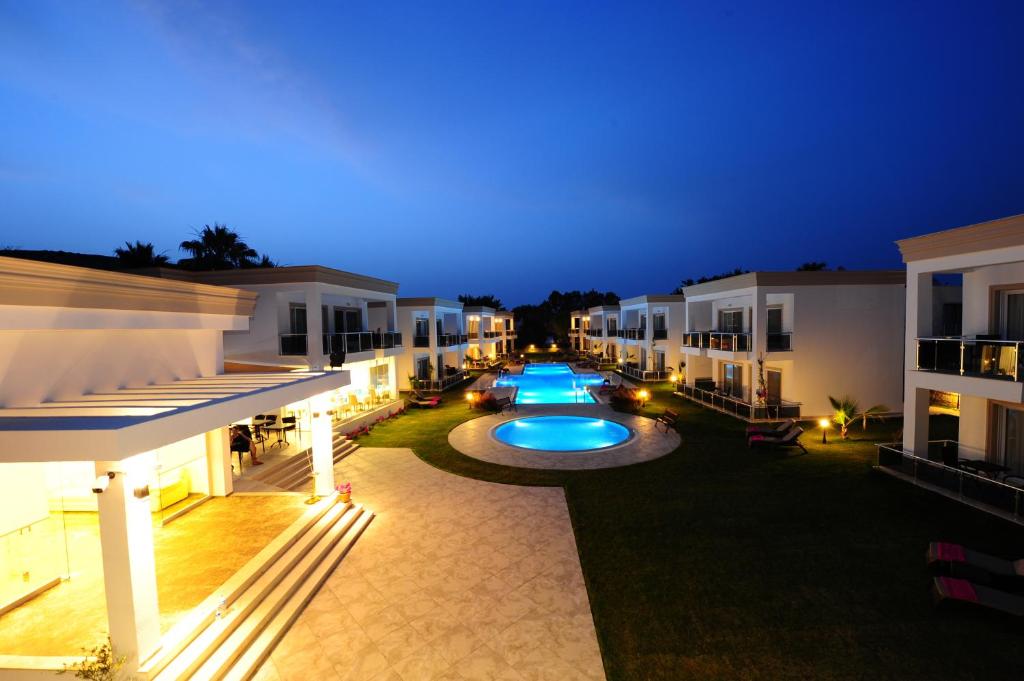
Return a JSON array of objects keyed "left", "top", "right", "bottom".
[{"left": 449, "top": 405, "right": 681, "bottom": 470}]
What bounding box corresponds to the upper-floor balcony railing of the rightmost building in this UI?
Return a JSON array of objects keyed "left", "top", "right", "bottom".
[{"left": 916, "top": 337, "right": 1024, "bottom": 381}]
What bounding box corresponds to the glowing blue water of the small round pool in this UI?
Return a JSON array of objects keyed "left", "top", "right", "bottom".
[{"left": 495, "top": 416, "right": 630, "bottom": 452}]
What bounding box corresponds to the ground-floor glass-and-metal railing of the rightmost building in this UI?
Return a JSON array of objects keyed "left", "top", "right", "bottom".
[{"left": 879, "top": 440, "right": 1024, "bottom": 521}]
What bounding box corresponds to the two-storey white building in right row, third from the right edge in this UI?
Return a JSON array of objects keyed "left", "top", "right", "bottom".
[{"left": 615, "top": 295, "right": 686, "bottom": 381}]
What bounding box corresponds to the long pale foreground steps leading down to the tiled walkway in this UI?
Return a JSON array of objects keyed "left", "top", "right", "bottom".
[{"left": 137, "top": 496, "right": 373, "bottom": 681}]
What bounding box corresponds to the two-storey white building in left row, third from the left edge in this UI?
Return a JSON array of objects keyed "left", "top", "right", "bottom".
[{"left": 397, "top": 298, "right": 469, "bottom": 391}]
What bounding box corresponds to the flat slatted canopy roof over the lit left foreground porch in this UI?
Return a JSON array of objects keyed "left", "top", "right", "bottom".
[{"left": 0, "top": 371, "right": 349, "bottom": 463}]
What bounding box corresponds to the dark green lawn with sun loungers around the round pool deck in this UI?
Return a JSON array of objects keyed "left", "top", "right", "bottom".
[{"left": 360, "top": 385, "right": 1024, "bottom": 680}]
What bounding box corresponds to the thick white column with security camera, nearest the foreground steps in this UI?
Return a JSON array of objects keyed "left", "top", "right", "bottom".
[{"left": 96, "top": 461, "right": 160, "bottom": 670}]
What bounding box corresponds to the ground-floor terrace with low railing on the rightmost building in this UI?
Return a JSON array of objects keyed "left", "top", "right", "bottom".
[{"left": 878, "top": 440, "right": 1024, "bottom": 524}]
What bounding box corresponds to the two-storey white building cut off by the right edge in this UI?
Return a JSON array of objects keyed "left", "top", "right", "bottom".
[{"left": 879, "top": 215, "right": 1024, "bottom": 521}]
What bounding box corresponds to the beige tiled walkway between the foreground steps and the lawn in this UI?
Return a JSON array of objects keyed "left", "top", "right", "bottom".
[{"left": 257, "top": 449, "right": 604, "bottom": 681}]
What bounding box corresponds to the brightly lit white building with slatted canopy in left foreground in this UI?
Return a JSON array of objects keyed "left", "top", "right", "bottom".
[{"left": 0, "top": 257, "right": 358, "bottom": 679}]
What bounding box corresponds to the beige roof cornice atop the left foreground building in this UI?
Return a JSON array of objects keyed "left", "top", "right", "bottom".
[{"left": 0, "top": 257, "right": 256, "bottom": 316}]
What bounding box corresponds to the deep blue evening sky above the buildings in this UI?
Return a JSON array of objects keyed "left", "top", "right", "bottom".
[{"left": 0, "top": 0, "right": 1024, "bottom": 304}]
